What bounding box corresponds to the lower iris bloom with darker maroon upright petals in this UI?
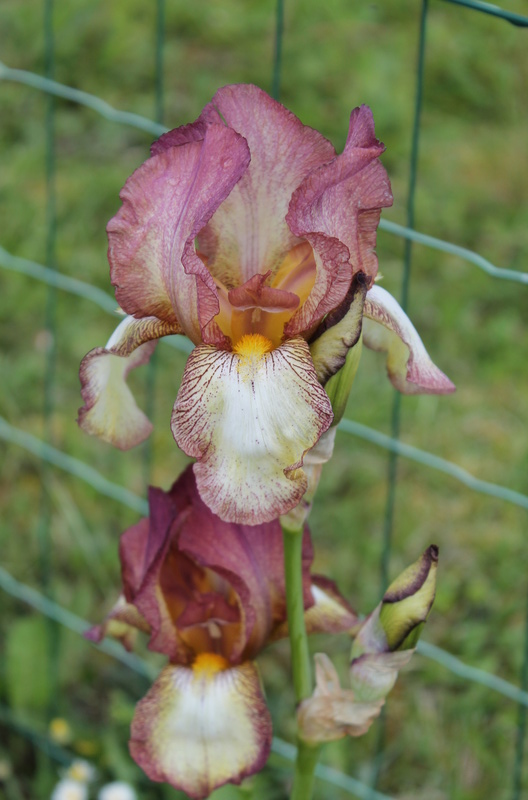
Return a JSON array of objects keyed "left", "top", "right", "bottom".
[{"left": 88, "top": 467, "right": 357, "bottom": 798}]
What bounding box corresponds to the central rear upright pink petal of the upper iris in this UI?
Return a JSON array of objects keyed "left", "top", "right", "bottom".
[{"left": 194, "top": 85, "right": 335, "bottom": 288}]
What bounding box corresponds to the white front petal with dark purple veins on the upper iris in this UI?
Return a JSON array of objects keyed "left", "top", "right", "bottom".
[{"left": 171, "top": 337, "right": 332, "bottom": 525}]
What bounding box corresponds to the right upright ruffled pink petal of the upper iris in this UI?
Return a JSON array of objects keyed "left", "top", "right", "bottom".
[{"left": 285, "top": 106, "right": 392, "bottom": 336}]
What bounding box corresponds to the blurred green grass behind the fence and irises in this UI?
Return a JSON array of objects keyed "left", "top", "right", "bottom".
[{"left": 0, "top": 0, "right": 528, "bottom": 800}]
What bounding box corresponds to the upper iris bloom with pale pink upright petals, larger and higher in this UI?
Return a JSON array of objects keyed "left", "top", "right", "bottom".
[{"left": 79, "top": 85, "right": 454, "bottom": 525}]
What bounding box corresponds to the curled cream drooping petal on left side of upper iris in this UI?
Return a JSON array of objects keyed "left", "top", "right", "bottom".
[{"left": 77, "top": 317, "right": 182, "bottom": 450}]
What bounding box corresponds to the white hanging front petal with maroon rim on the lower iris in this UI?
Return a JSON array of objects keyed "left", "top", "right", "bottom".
[{"left": 130, "top": 653, "right": 271, "bottom": 800}]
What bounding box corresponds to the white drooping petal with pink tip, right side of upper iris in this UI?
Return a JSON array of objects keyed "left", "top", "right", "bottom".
[{"left": 363, "top": 286, "right": 455, "bottom": 394}]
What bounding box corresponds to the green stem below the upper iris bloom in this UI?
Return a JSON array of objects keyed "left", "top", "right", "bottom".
[{"left": 282, "top": 526, "right": 320, "bottom": 800}]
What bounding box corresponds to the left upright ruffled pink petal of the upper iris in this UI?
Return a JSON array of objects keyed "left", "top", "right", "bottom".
[{"left": 107, "top": 124, "right": 250, "bottom": 343}]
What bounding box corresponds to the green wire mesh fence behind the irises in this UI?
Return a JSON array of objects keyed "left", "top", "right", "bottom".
[{"left": 0, "top": 0, "right": 528, "bottom": 800}]
